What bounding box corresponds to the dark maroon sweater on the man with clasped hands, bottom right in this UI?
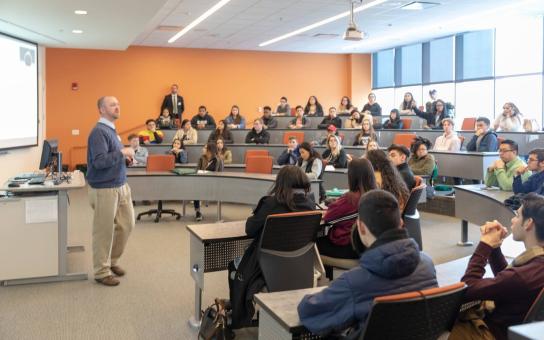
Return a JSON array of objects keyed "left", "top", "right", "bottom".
[{"left": 461, "top": 242, "right": 544, "bottom": 339}]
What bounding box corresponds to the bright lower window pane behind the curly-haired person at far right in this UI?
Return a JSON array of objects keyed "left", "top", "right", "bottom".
[{"left": 495, "top": 74, "right": 542, "bottom": 124}]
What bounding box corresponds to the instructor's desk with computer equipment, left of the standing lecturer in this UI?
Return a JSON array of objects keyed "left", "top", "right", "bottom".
[{"left": 0, "top": 171, "right": 87, "bottom": 285}]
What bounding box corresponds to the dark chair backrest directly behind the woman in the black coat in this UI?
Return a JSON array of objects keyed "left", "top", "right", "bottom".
[{"left": 258, "top": 211, "right": 321, "bottom": 292}]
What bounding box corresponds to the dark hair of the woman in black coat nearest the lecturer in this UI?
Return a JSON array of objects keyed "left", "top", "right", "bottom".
[{"left": 270, "top": 165, "right": 310, "bottom": 211}]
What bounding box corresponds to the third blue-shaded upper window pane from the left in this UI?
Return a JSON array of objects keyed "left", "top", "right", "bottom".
[{"left": 429, "top": 37, "right": 455, "bottom": 83}]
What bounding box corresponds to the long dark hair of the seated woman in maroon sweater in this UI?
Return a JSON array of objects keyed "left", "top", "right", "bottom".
[{"left": 348, "top": 158, "right": 378, "bottom": 204}]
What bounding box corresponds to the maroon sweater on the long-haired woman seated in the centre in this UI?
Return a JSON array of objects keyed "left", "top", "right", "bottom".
[{"left": 323, "top": 192, "right": 361, "bottom": 246}]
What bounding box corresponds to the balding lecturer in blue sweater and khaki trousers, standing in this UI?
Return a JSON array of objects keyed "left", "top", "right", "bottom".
[{"left": 87, "top": 96, "right": 134, "bottom": 286}]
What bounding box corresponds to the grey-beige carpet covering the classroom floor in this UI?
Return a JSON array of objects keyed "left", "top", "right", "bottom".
[{"left": 0, "top": 190, "right": 479, "bottom": 339}]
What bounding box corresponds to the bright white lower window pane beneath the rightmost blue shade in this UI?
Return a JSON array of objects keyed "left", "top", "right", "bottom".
[{"left": 455, "top": 80, "right": 494, "bottom": 126}]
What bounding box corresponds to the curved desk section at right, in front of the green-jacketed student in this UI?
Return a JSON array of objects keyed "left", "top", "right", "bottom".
[{"left": 455, "top": 184, "right": 514, "bottom": 246}]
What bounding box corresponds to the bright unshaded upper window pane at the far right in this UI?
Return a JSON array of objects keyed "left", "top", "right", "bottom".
[{"left": 495, "top": 17, "right": 542, "bottom": 76}]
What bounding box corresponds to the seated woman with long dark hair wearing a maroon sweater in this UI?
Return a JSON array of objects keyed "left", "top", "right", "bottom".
[{"left": 317, "top": 158, "right": 377, "bottom": 259}]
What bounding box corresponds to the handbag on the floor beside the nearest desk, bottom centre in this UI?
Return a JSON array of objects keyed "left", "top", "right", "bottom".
[{"left": 198, "top": 299, "right": 233, "bottom": 340}]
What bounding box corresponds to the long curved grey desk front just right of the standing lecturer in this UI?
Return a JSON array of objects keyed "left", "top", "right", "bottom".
[{"left": 127, "top": 170, "right": 319, "bottom": 220}]
